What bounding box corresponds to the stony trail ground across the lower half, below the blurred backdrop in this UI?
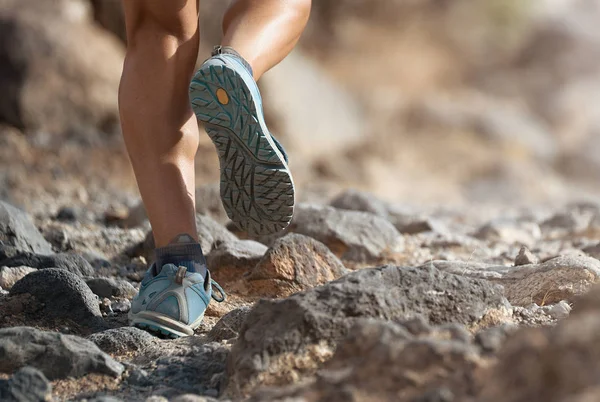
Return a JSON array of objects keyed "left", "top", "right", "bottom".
[{"left": 0, "top": 186, "right": 600, "bottom": 402}]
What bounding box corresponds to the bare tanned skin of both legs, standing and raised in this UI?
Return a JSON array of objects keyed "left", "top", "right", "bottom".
[{"left": 119, "top": 0, "right": 311, "bottom": 247}]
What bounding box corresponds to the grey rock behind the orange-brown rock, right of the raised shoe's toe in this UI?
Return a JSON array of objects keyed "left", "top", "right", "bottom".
[{"left": 289, "top": 205, "right": 404, "bottom": 262}]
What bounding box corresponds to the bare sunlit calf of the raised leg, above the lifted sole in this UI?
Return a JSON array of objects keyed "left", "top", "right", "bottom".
[{"left": 222, "top": 0, "right": 311, "bottom": 80}]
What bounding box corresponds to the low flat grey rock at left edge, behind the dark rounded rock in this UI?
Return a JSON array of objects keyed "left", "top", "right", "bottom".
[{"left": 0, "top": 253, "right": 95, "bottom": 276}]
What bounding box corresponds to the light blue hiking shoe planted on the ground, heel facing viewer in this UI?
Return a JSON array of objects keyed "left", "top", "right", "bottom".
[{"left": 129, "top": 264, "right": 226, "bottom": 338}]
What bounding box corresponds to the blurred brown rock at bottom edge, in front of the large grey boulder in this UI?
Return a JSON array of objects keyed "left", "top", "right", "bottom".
[{"left": 251, "top": 320, "right": 483, "bottom": 402}]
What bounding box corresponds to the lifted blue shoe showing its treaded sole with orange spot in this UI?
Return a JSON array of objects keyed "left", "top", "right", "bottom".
[{"left": 190, "top": 47, "right": 294, "bottom": 235}]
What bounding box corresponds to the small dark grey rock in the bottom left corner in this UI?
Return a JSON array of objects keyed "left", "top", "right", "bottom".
[{"left": 0, "top": 368, "right": 52, "bottom": 402}]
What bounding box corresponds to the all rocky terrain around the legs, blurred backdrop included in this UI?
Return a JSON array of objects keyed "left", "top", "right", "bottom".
[{"left": 5, "top": 0, "right": 600, "bottom": 402}]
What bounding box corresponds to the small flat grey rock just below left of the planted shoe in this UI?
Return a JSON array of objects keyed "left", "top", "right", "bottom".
[{"left": 86, "top": 327, "right": 160, "bottom": 354}]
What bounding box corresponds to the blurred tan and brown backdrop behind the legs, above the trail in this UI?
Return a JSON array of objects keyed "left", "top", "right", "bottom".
[{"left": 0, "top": 0, "right": 600, "bottom": 220}]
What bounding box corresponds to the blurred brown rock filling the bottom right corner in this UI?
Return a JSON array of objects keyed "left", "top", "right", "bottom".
[{"left": 478, "top": 287, "right": 600, "bottom": 402}]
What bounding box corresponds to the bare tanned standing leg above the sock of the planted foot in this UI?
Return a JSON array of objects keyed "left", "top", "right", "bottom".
[{"left": 119, "top": 0, "right": 199, "bottom": 247}]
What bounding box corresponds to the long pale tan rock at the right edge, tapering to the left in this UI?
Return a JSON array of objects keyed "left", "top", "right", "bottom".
[{"left": 425, "top": 255, "right": 600, "bottom": 306}]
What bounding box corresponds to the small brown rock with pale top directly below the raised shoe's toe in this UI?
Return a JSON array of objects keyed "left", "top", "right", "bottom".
[{"left": 206, "top": 240, "right": 267, "bottom": 283}]
